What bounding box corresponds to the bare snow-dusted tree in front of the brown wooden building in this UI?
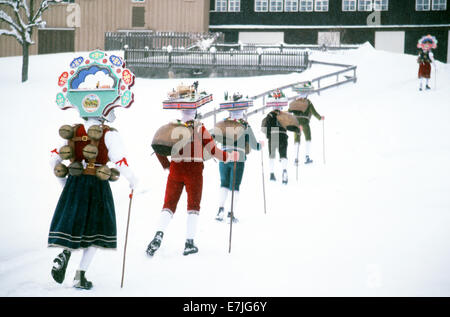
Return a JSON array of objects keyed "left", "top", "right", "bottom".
[{"left": 0, "top": 0, "right": 56, "bottom": 82}]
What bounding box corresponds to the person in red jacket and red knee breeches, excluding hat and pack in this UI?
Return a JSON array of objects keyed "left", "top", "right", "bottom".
[{"left": 147, "top": 109, "right": 239, "bottom": 256}]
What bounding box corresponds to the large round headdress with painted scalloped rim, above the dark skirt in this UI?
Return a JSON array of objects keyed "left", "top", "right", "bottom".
[{"left": 56, "top": 50, "right": 135, "bottom": 118}]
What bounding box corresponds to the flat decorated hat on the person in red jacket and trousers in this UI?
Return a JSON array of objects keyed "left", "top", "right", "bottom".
[{"left": 163, "top": 81, "right": 213, "bottom": 110}]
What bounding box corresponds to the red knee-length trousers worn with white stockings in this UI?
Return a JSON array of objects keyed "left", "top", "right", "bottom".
[{"left": 163, "top": 161, "right": 203, "bottom": 213}]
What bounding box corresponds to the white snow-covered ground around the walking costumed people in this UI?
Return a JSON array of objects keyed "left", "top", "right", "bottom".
[{"left": 0, "top": 44, "right": 450, "bottom": 297}]
